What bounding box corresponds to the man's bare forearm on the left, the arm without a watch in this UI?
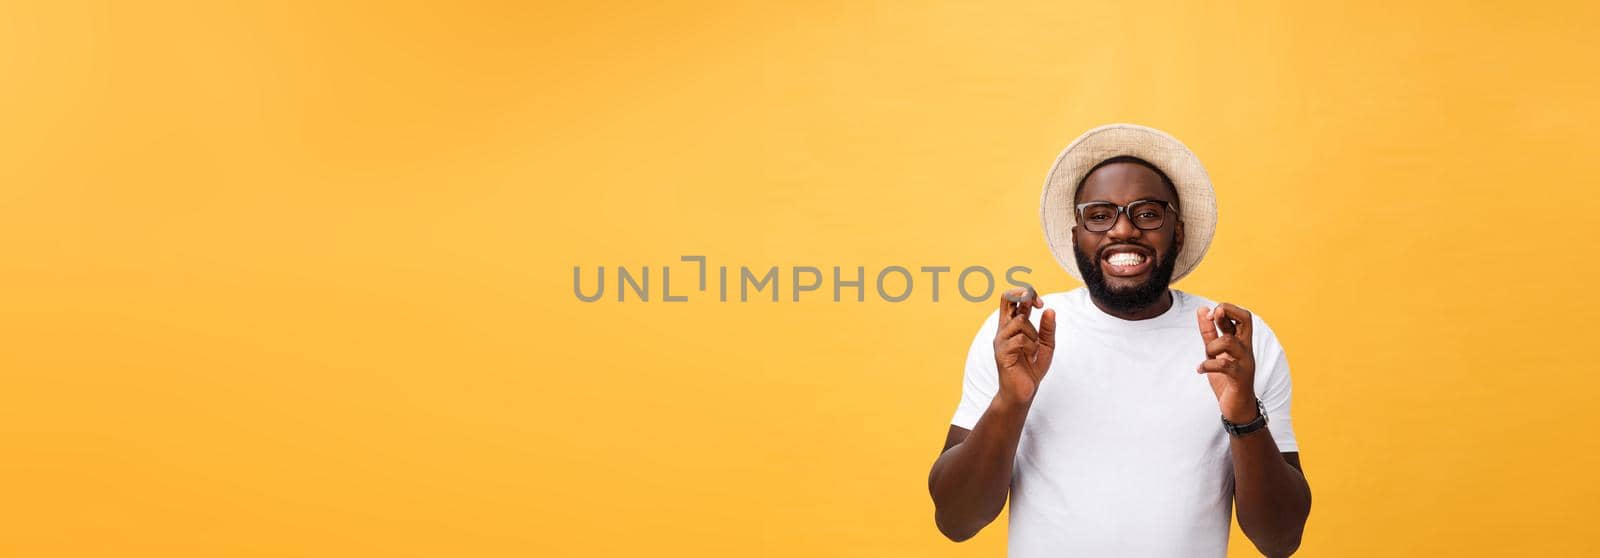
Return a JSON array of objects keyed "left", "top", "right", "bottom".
[{"left": 928, "top": 398, "right": 1027, "bottom": 540}]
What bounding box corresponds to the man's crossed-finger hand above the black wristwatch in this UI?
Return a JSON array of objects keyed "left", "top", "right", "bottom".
[{"left": 1195, "top": 302, "right": 1258, "bottom": 424}]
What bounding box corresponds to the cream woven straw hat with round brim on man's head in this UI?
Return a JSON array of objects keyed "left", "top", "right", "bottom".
[{"left": 1038, "top": 125, "right": 1216, "bottom": 283}]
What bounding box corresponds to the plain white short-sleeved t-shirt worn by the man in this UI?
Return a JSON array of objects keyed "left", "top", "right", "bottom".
[{"left": 950, "top": 288, "right": 1299, "bottom": 558}]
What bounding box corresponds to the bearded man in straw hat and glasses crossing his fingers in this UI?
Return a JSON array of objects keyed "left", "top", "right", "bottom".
[{"left": 928, "top": 125, "right": 1310, "bottom": 556}]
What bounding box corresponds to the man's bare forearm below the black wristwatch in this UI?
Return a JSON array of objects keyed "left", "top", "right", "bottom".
[{"left": 1230, "top": 428, "right": 1310, "bottom": 556}]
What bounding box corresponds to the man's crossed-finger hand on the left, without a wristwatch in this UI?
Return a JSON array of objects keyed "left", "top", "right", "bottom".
[{"left": 995, "top": 288, "right": 1056, "bottom": 406}]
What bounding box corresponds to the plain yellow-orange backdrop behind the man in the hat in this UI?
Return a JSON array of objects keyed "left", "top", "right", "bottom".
[{"left": 0, "top": 2, "right": 1600, "bottom": 556}]
